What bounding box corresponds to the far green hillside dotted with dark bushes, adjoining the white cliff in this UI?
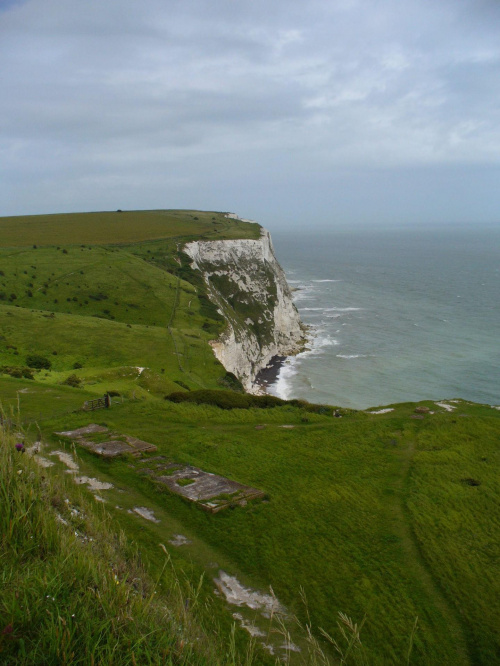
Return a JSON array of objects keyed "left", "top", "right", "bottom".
[{"left": 0, "top": 211, "right": 260, "bottom": 395}]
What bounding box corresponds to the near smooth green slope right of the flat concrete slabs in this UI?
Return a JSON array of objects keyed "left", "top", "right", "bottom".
[{"left": 38, "top": 402, "right": 500, "bottom": 664}]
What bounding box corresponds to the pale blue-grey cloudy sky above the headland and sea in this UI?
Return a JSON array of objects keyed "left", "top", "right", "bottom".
[{"left": 0, "top": 0, "right": 500, "bottom": 230}]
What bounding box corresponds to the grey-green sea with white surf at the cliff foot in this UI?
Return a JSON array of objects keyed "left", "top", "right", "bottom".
[{"left": 268, "top": 225, "right": 500, "bottom": 409}]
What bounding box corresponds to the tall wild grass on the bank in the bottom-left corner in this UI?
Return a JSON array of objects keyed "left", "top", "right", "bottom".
[{"left": 0, "top": 420, "right": 254, "bottom": 666}]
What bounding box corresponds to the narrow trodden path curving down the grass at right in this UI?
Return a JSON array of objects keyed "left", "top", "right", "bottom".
[{"left": 394, "top": 439, "right": 473, "bottom": 666}]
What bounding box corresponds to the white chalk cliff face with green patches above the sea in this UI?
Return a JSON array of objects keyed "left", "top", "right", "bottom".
[{"left": 183, "top": 229, "right": 304, "bottom": 393}]
